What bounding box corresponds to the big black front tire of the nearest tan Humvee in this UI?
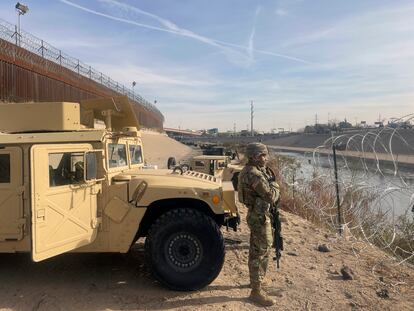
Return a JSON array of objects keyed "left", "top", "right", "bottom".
[{"left": 145, "top": 208, "right": 224, "bottom": 291}]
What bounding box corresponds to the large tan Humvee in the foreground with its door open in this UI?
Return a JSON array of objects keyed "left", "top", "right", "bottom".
[{"left": 0, "top": 97, "right": 238, "bottom": 290}]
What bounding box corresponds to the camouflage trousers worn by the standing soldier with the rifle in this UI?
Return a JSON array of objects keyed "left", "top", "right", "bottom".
[{"left": 247, "top": 205, "right": 273, "bottom": 288}]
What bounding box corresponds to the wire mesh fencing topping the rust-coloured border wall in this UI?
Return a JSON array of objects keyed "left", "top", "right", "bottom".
[{"left": 0, "top": 19, "right": 164, "bottom": 122}]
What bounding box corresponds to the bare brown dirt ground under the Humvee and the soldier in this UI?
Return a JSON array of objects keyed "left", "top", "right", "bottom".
[{"left": 0, "top": 135, "right": 414, "bottom": 311}]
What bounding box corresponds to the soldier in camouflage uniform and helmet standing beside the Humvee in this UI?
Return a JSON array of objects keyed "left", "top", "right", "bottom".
[{"left": 238, "top": 143, "right": 279, "bottom": 306}]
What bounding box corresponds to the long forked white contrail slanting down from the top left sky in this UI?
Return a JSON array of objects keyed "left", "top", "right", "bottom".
[{"left": 59, "top": 0, "right": 313, "bottom": 64}]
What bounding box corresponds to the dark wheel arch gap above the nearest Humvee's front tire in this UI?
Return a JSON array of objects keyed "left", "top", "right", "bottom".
[{"left": 135, "top": 198, "right": 224, "bottom": 240}]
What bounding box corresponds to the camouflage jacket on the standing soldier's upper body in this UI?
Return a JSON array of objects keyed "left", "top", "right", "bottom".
[{"left": 238, "top": 163, "right": 280, "bottom": 207}]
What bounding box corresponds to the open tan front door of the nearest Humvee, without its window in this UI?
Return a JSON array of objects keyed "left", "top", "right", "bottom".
[{"left": 31, "top": 144, "right": 98, "bottom": 261}]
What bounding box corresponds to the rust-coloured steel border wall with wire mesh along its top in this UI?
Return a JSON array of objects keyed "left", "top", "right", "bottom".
[{"left": 0, "top": 19, "right": 164, "bottom": 129}]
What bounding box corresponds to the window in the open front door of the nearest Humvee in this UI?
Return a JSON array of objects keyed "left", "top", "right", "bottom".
[{"left": 49, "top": 152, "right": 84, "bottom": 187}]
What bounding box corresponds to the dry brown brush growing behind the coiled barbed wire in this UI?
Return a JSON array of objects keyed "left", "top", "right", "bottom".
[{"left": 269, "top": 156, "right": 414, "bottom": 263}]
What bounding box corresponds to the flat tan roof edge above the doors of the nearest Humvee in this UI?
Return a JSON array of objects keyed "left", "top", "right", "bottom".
[{"left": 0, "top": 129, "right": 107, "bottom": 145}]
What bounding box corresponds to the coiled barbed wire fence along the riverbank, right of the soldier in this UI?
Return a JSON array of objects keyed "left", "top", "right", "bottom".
[{"left": 274, "top": 114, "right": 414, "bottom": 263}]
